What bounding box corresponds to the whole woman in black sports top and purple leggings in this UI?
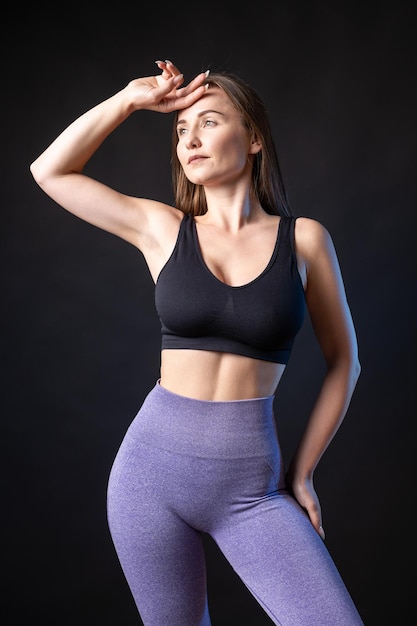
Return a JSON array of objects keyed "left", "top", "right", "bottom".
[{"left": 31, "top": 61, "right": 362, "bottom": 626}]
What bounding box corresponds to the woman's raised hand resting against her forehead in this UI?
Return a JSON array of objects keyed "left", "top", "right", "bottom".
[{"left": 125, "top": 61, "right": 208, "bottom": 113}]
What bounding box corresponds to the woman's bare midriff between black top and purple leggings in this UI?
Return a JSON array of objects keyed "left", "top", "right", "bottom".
[{"left": 160, "top": 350, "right": 285, "bottom": 402}]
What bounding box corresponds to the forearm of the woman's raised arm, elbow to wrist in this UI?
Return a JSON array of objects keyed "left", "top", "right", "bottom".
[{"left": 30, "top": 90, "right": 132, "bottom": 184}]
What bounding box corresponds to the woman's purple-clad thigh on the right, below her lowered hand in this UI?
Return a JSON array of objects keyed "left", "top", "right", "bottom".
[{"left": 215, "top": 493, "right": 363, "bottom": 626}]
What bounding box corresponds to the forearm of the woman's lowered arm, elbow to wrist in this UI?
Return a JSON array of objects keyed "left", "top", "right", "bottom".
[{"left": 289, "top": 359, "right": 360, "bottom": 481}]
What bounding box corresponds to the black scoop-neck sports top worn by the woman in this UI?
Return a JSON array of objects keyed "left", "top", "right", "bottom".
[{"left": 155, "top": 215, "right": 306, "bottom": 364}]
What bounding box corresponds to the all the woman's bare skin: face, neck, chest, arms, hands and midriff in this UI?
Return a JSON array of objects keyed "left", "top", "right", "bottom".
[{"left": 30, "top": 61, "right": 360, "bottom": 539}]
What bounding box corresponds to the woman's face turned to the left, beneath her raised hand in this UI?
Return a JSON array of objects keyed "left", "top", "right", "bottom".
[{"left": 177, "top": 87, "right": 260, "bottom": 186}]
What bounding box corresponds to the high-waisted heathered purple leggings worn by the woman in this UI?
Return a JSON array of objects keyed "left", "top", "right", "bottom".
[{"left": 108, "top": 382, "right": 363, "bottom": 626}]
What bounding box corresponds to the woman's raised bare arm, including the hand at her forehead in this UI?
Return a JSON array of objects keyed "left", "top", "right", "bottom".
[{"left": 30, "top": 61, "right": 206, "bottom": 249}]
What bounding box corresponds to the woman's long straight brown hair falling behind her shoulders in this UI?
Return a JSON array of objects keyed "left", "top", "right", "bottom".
[{"left": 171, "top": 72, "right": 292, "bottom": 215}]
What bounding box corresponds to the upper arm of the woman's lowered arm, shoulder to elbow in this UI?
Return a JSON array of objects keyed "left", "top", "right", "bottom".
[{"left": 295, "top": 218, "right": 357, "bottom": 364}]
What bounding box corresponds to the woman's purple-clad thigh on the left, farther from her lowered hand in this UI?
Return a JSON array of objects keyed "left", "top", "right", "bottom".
[{"left": 107, "top": 442, "right": 210, "bottom": 626}]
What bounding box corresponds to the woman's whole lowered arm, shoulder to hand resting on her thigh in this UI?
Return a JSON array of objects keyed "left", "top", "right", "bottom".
[{"left": 287, "top": 218, "right": 360, "bottom": 538}]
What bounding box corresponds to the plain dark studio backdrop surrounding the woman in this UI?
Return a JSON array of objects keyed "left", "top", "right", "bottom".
[{"left": 1, "top": 0, "right": 417, "bottom": 626}]
